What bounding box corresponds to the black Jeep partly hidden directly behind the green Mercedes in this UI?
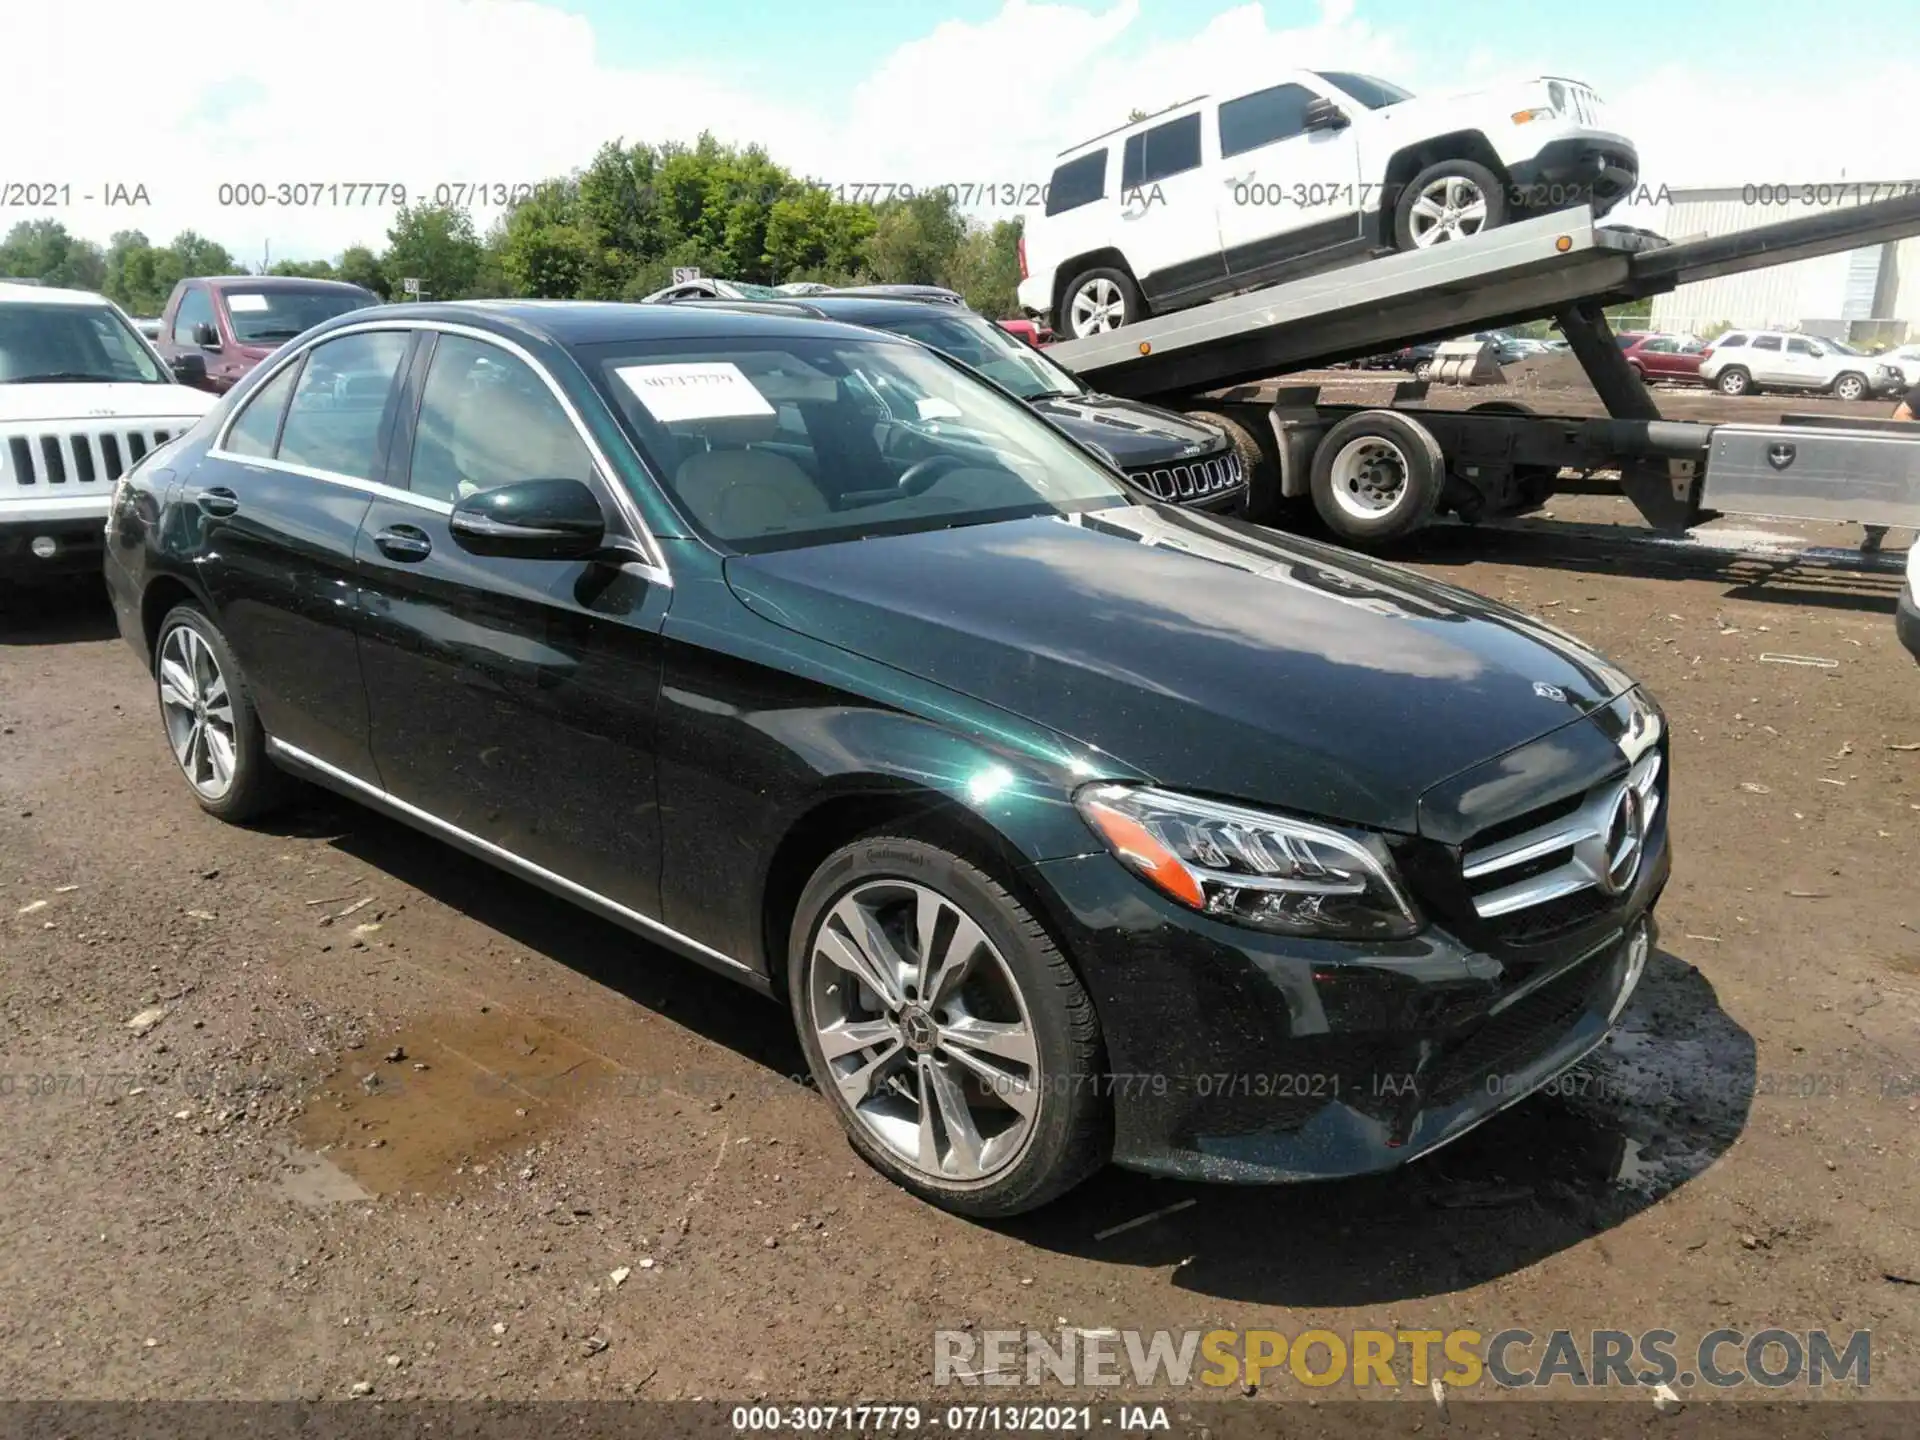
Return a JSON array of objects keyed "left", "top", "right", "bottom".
[{"left": 652, "top": 286, "right": 1252, "bottom": 515}]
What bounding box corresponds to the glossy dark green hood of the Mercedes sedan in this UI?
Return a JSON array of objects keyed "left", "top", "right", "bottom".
[{"left": 728, "top": 505, "right": 1632, "bottom": 833}]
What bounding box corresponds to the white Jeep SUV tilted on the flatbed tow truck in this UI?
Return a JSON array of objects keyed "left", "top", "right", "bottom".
[{"left": 1020, "top": 71, "right": 1640, "bottom": 340}]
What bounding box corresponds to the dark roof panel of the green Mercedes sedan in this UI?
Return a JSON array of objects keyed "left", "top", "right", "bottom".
[{"left": 324, "top": 296, "right": 902, "bottom": 346}]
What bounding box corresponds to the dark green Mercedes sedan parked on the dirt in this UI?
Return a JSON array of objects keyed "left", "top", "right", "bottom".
[{"left": 108, "top": 301, "right": 1668, "bottom": 1215}]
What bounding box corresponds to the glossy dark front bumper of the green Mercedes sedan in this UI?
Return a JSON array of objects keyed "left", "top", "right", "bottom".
[{"left": 1039, "top": 824, "right": 1670, "bottom": 1183}]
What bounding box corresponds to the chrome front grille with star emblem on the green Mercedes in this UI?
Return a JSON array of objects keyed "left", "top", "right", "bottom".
[{"left": 1461, "top": 741, "right": 1665, "bottom": 920}]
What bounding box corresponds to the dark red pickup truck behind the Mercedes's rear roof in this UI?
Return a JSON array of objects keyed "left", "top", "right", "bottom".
[{"left": 154, "top": 275, "right": 380, "bottom": 396}]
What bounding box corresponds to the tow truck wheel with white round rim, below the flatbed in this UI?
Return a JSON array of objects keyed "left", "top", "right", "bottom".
[{"left": 1311, "top": 411, "right": 1446, "bottom": 547}]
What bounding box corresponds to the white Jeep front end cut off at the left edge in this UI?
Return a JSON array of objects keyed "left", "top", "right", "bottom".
[{"left": 0, "top": 284, "right": 219, "bottom": 580}]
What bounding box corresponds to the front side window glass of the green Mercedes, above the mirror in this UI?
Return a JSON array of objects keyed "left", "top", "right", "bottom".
[{"left": 409, "top": 334, "right": 593, "bottom": 505}]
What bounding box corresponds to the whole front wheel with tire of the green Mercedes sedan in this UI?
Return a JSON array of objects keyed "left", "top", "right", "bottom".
[{"left": 787, "top": 835, "right": 1106, "bottom": 1217}]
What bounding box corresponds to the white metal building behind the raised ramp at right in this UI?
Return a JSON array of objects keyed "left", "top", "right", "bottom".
[{"left": 1653, "top": 180, "right": 1920, "bottom": 342}]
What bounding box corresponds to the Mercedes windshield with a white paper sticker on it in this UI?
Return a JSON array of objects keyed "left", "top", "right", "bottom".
[{"left": 580, "top": 336, "right": 1131, "bottom": 553}]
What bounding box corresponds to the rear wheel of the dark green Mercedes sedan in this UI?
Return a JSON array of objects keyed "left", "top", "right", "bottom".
[{"left": 154, "top": 605, "right": 288, "bottom": 824}]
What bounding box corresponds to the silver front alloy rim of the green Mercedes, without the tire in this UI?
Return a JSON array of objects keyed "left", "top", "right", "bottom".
[{"left": 806, "top": 879, "right": 1043, "bottom": 1183}]
